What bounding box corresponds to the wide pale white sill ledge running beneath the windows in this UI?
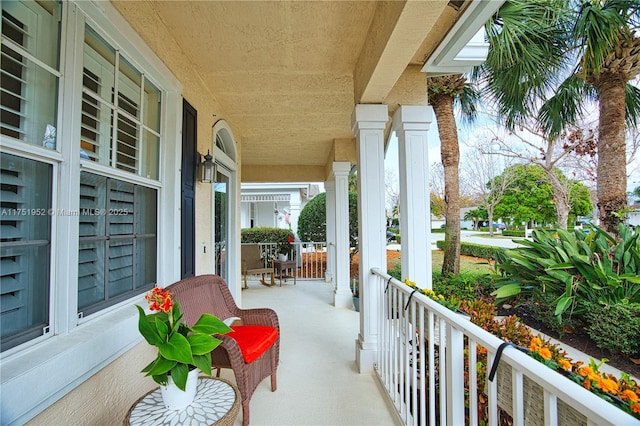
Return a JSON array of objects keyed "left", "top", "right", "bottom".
[{"left": 0, "top": 304, "right": 142, "bottom": 425}]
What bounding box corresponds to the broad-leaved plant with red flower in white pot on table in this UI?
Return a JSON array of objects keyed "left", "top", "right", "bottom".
[{"left": 136, "top": 287, "right": 231, "bottom": 409}]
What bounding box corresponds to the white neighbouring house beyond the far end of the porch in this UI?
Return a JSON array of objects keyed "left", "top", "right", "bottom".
[{"left": 240, "top": 183, "right": 319, "bottom": 235}]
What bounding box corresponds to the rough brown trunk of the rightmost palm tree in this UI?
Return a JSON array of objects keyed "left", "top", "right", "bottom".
[{"left": 596, "top": 74, "right": 627, "bottom": 238}]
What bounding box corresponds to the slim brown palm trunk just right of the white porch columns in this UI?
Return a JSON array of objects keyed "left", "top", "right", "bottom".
[{"left": 431, "top": 95, "right": 460, "bottom": 277}]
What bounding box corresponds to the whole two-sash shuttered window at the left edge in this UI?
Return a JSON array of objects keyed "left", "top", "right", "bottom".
[{"left": 0, "top": 1, "right": 61, "bottom": 351}]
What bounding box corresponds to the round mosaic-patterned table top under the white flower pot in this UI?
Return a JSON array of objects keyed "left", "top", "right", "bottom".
[{"left": 127, "top": 377, "right": 240, "bottom": 426}]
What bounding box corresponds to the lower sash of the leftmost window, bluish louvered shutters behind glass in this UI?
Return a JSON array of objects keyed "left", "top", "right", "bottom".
[{"left": 0, "top": 153, "right": 52, "bottom": 349}]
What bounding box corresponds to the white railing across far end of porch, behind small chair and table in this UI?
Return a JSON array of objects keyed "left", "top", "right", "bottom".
[{"left": 242, "top": 241, "right": 327, "bottom": 279}]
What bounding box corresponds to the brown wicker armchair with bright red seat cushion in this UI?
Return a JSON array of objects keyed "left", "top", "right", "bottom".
[{"left": 167, "top": 275, "right": 280, "bottom": 425}]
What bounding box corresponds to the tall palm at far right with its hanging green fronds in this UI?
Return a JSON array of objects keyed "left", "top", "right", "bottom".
[{"left": 482, "top": 0, "right": 640, "bottom": 240}]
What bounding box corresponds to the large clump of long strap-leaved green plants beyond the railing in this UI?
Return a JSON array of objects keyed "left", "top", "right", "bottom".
[{"left": 493, "top": 225, "right": 640, "bottom": 322}]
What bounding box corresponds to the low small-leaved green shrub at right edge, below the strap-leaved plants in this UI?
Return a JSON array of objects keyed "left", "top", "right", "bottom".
[{"left": 584, "top": 303, "right": 640, "bottom": 355}]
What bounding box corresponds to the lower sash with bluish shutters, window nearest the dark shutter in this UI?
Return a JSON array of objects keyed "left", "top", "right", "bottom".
[{"left": 78, "top": 171, "right": 157, "bottom": 315}]
